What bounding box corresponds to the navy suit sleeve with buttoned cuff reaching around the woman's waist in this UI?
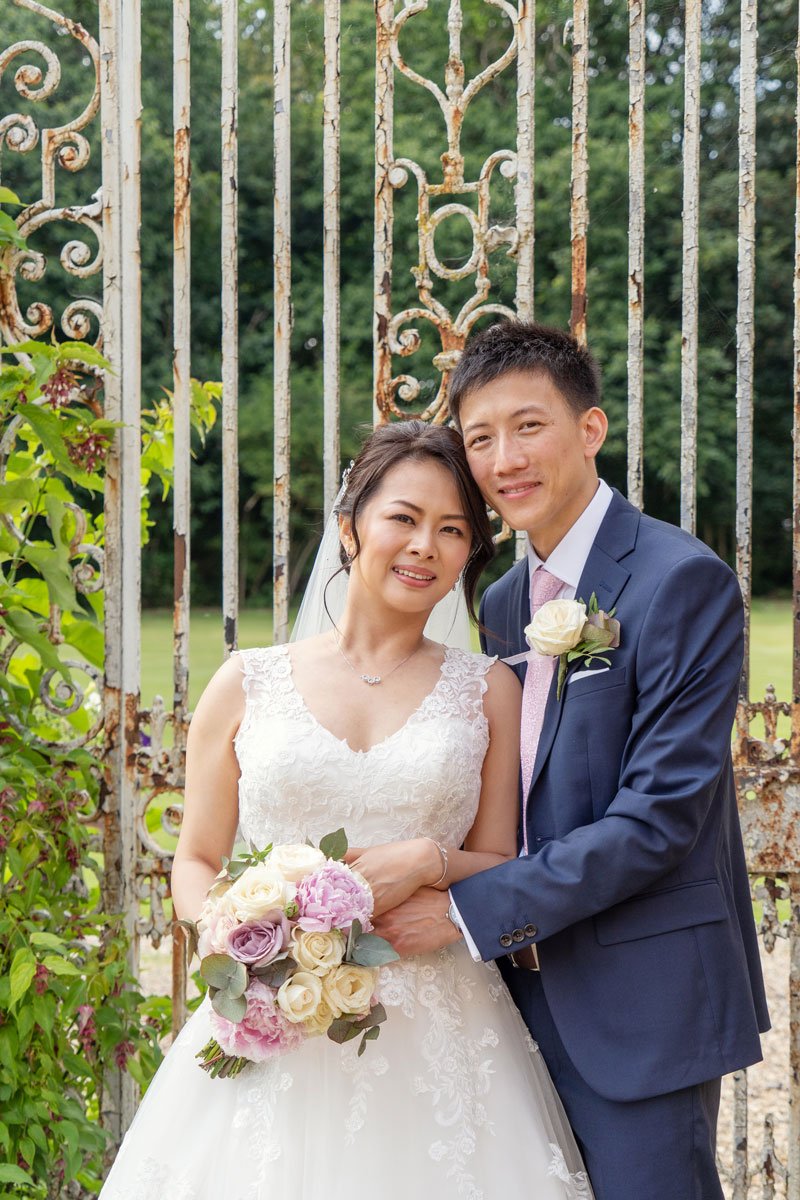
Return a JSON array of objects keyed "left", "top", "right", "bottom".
[{"left": 452, "top": 554, "right": 744, "bottom": 960}]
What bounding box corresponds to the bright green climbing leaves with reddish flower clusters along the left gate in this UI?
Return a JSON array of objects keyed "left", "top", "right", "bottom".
[{"left": 0, "top": 342, "right": 218, "bottom": 1198}]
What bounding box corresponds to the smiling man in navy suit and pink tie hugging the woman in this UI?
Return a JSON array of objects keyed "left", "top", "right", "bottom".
[{"left": 381, "top": 322, "right": 769, "bottom": 1200}]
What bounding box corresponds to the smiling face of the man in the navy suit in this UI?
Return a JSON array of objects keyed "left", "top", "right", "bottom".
[{"left": 459, "top": 371, "right": 608, "bottom": 558}]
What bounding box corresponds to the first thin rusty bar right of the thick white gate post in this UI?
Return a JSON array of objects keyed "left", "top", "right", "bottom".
[{"left": 173, "top": 0, "right": 192, "bottom": 1034}]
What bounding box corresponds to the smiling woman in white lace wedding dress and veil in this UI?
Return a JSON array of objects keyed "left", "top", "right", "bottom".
[{"left": 101, "top": 421, "right": 591, "bottom": 1200}]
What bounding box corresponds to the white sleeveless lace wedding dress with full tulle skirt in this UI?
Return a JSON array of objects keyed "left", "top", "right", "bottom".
[{"left": 101, "top": 647, "right": 591, "bottom": 1200}]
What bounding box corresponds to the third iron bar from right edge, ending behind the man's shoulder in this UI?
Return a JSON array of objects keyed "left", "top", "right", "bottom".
[{"left": 680, "top": 0, "right": 702, "bottom": 533}]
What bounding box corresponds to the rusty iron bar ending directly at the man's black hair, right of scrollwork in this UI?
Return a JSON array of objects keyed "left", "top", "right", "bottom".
[{"left": 570, "top": 0, "right": 589, "bottom": 346}]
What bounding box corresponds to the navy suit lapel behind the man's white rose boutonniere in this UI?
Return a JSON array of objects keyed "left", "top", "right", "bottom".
[{"left": 528, "top": 488, "right": 639, "bottom": 796}]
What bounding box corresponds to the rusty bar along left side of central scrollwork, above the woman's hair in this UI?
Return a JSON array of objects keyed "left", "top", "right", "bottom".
[{"left": 373, "top": 0, "right": 395, "bottom": 425}]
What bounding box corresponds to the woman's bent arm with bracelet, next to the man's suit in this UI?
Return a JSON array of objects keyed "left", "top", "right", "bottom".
[{"left": 347, "top": 662, "right": 522, "bottom": 914}]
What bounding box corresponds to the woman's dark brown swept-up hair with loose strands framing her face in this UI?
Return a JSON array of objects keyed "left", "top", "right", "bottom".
[{"left": 337, "top": 420, "right": 494, "bottom": 624}]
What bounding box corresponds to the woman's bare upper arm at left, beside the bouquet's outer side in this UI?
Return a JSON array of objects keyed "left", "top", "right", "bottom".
[{"left": 172, "top": 655, "right": 245, "bottom": 920}]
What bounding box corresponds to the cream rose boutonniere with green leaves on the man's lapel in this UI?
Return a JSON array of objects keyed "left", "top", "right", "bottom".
[{"left": 525, "top": 592, "right": 620, "bottom": 700}]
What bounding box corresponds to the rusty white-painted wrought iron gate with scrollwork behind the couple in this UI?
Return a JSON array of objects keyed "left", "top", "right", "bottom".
[{"left": 0, "top": 0, "right": 800, "bottom": 1200}]
